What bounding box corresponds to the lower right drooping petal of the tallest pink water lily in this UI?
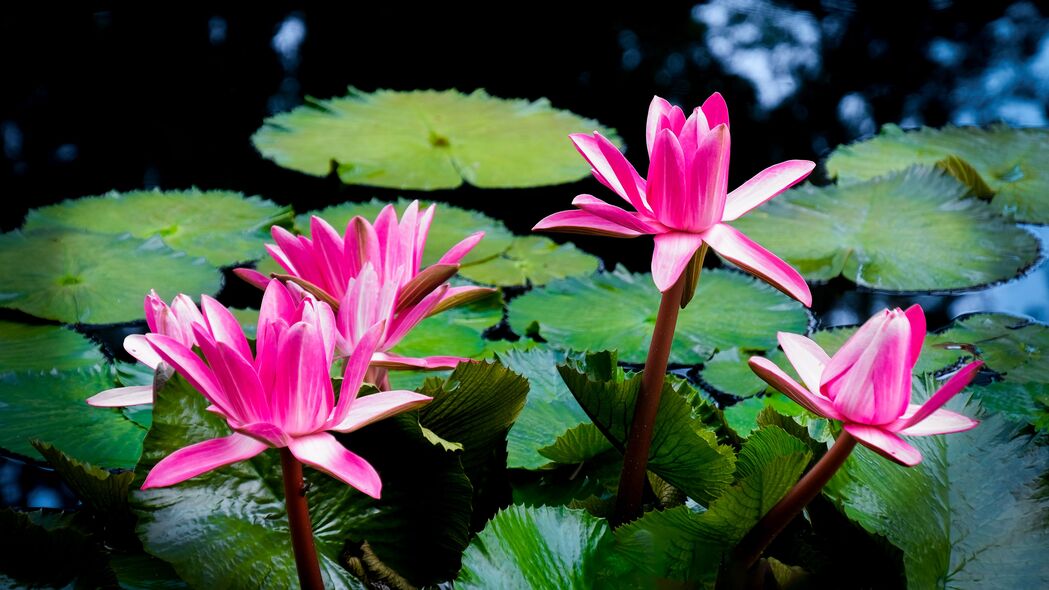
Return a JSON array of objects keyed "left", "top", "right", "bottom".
[{"left": 701, "top": 224, "right": 812, "bottom": 308}]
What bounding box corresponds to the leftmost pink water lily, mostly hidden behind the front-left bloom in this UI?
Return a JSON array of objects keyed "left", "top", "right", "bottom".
[{"left": 87, "top": 290, "right": 205, "bottom": 407}]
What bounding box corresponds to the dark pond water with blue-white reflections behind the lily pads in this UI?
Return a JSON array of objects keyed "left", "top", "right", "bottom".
[{"left": 0, "top": 0, "right": 1049, "bottom": 506}]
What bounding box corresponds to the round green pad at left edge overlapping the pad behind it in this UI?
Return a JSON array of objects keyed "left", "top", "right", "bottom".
[{"left": 0, "top": 230, "right": 222, "bottom": 323}]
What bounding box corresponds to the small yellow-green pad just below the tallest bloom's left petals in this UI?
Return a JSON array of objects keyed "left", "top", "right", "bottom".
[{"left": 459, "top": 235, "right": 601, "bottom": 287}]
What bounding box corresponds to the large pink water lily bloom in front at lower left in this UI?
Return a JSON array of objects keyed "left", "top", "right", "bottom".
[{"left": 142, "top": 280, "right": 430, "bottom": 498}]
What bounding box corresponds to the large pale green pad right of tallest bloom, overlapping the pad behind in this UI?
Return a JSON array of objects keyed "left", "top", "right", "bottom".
[{"left": 732, "top": 167, "right": 1041, "bottom": 292}]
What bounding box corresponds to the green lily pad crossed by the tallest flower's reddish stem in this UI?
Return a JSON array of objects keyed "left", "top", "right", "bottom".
[{"left": 509, "top": 269, "right": 809, "bottom": 364}]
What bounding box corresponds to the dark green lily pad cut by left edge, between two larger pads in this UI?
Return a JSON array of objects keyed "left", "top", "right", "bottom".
[{"left": 0, "top": 321, "right": 106, "bottom": 373}]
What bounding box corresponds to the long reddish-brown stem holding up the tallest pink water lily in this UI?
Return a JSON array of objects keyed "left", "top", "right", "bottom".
[{"left": 613, "top": 274, "right": 685, "bottom": 526}]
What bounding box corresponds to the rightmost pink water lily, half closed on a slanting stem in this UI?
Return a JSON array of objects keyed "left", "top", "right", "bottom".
[{"left": 750, "top": 305, "right": 983, "bottom": 466}]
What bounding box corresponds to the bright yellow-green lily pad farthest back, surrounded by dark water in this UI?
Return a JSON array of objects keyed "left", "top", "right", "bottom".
[{"left": 252, "top": 88, "right": 617, "bottom": 190}]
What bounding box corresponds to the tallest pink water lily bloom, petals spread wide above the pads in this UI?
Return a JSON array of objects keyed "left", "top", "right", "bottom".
[{"left": 534, "top": 92, "right": 815, "bottom": 305}]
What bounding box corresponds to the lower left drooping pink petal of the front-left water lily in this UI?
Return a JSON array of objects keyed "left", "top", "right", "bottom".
[{"left": 142, "top": 434, "right": 267, "bottom": 489}]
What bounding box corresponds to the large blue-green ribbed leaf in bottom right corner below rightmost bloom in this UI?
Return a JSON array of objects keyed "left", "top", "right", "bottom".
[{"left": 823, "top": 396, "right": 1049, "bottom": 588}]
